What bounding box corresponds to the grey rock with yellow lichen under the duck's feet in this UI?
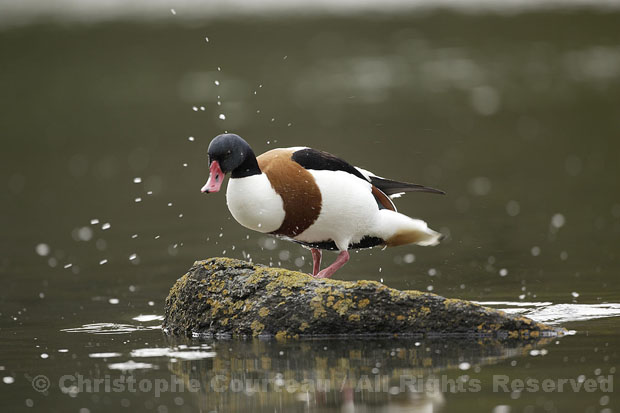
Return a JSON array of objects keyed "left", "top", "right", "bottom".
[{"left": 164, "top": 258, "right": 564, "bottom": 340}]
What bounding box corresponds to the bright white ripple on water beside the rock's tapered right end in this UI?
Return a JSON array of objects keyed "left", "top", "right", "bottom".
[{"left": 478, "top": 301, "right": 620, "bottom": 324}]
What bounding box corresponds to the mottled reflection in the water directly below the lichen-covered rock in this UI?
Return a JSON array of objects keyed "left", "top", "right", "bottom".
[{"left": 169, "top": 338, "right": 548, "bottom": 412}]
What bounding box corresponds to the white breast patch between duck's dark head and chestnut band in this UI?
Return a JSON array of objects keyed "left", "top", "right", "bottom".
[{"left": 226, "top": 174, "right": 285, "bottom": 233}]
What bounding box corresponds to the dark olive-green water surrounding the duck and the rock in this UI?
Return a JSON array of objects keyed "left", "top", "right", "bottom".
[{"left": 0, "top": 7, "right": 620, "bottom": 413}]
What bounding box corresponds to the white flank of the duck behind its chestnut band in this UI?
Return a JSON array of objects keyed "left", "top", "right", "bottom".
[{"left": 295, "top": 170, "right": 379, "bottom": 249}]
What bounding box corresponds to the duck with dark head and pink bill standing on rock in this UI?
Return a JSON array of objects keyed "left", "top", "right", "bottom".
[{"left": 201, "top": 133, "right": 445, "bottom": 278}]
